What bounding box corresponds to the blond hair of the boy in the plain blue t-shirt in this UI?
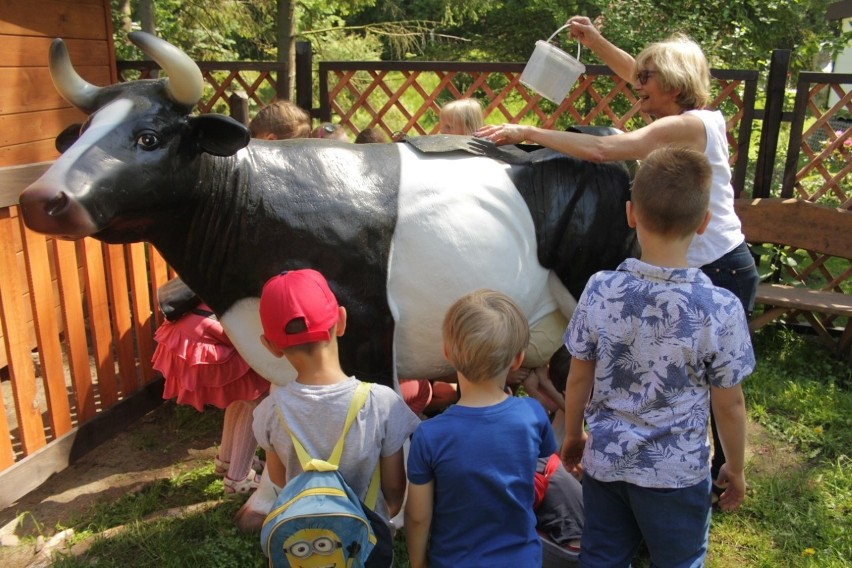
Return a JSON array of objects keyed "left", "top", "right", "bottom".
[{"left": 442, "top": 289, "right": 530, "bottom": 382}]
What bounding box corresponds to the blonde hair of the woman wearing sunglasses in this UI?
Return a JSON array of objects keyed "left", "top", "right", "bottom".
[{"left": 633, "top": 33, "right": 710, "bottom": 110}]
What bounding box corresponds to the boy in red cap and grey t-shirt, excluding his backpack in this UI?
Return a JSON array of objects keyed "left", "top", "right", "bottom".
[{"left": 240, "top": 269, "right": 420, "bottom": 540}]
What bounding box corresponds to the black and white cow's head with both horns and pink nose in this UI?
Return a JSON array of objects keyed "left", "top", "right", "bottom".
[{"left": 19, "top": 32, "right": 249, "bottom": 242}]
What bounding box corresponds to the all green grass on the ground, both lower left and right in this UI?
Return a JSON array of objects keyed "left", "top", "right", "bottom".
[{"left": 36, "top": 327, "right": 852, "bottom": 568}]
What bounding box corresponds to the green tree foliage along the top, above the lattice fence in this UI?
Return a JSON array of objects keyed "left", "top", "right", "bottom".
[{"left": 112, "top": 0, "right": 852, "bottom": 80}]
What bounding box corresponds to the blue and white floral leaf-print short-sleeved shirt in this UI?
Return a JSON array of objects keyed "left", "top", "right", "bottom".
[{"left": 564, "top": 258, "right": 755, "bottom": 488}]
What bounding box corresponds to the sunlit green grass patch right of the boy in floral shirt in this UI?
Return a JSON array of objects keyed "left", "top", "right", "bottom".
[{"left": 710, "top": 328, "right": 852, "bottom": 568}]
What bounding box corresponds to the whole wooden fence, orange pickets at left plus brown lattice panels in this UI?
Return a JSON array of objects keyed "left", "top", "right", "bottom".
[{"left": 0, "top": 45, "right": 852, "bottom": 507}]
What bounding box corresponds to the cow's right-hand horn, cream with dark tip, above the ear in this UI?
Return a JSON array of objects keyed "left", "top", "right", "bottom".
[{"left": 127, "top": 32, "right": 204, "bottom": 107}]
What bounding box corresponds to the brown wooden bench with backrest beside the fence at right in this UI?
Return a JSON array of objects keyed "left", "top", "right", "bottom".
[{"left": 736, "top": 198, "right": 852, "bottom": 360}]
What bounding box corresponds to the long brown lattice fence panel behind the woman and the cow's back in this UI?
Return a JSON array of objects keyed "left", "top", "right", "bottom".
[{"left": 319, "top": 62, "right": 757, "bottom": 179}]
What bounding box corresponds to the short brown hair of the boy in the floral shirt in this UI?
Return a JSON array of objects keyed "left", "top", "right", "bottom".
[{"left": 630, "top": 147, "right": 713, "bottom": 238}]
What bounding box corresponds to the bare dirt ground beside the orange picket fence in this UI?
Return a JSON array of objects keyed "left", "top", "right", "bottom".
[{"left": 0, "top": 402, "right": 222, "bottom": 568}]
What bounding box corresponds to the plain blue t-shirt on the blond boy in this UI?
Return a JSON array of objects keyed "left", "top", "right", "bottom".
[{"left": 408, "top": 397, "right": 556, "bottom": 568}]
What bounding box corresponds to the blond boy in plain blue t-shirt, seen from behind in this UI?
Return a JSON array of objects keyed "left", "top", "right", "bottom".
[{"left": 405, "top": 290, "right": 556, "bottom": 568}]
